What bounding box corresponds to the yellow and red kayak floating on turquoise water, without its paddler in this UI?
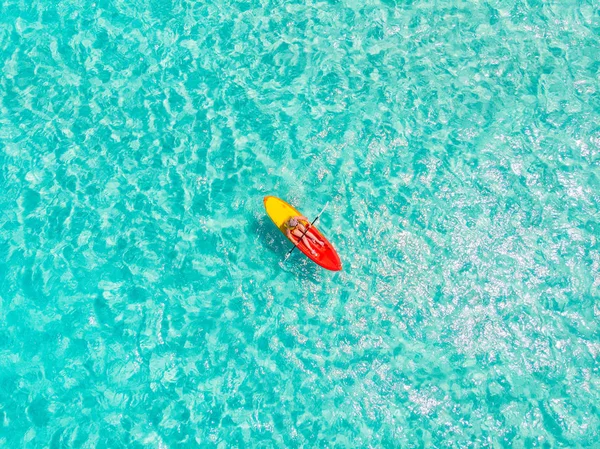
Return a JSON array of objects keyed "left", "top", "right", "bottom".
[{"left": 263, "top": 196, "right": 342, "bottom": 271}]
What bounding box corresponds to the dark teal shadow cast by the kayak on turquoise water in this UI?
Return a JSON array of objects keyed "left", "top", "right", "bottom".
[{"left": 251, "top": 219, "right": 321, "bottom": 282}]
